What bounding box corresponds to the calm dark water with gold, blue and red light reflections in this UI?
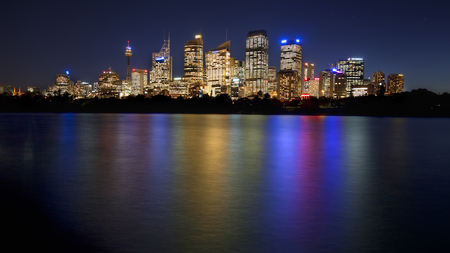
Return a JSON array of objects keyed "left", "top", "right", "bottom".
[{"left": 0, "top": 114, "right": 450, "bottom": 252}]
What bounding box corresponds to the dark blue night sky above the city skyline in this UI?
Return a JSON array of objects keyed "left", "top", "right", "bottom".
[{"left": 0, "top": 0, "right": 450, "bottom": 92}]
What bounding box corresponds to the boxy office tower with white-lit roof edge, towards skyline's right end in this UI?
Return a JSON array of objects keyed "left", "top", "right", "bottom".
[{"left": 336, "top": 58, "right": 364, "bottom": 97}]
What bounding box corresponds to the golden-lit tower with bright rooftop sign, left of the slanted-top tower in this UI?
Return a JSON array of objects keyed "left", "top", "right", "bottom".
[{"left": 184, "top": 34, "right": 203, "bottom": 84}]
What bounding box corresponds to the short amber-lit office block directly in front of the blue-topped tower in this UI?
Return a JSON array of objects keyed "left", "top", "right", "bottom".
[{"left": 277, "top": 70, "right": 300, "bottom": 100}]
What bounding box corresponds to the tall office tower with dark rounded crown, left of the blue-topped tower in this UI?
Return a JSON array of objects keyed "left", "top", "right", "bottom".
[{"left": 245, "top": 30, "right": 269, "bottom": 96}]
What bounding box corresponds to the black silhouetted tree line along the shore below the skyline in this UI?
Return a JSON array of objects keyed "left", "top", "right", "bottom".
[{"left": 0, "top": 89, "right": 450, "bottom": 117}]
